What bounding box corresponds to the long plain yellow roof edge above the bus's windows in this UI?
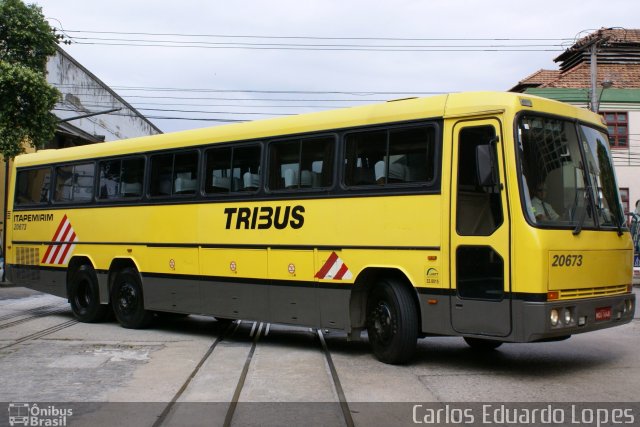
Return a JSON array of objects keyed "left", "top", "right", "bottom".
[{"left": 15, "top": 92, "right": 602, "bottom": 167}]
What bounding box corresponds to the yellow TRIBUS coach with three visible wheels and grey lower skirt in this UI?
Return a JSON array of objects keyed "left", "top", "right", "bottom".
[{"left": 6, "top": 92, "right": 635, "bottom": 363}]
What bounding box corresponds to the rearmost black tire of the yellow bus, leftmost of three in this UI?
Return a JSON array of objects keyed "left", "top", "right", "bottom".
[{"left": 67, "top": 264, "right": 109, "bottom": 323}]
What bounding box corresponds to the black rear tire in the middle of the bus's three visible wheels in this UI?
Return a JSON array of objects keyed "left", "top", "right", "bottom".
[{"left": 111, "top": 267, "right": 153, "bottom": 329}]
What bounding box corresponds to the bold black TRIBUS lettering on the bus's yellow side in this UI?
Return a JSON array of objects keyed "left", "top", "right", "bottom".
[{"left": 224, "top": 206, "right": 304, "bottom": 230}]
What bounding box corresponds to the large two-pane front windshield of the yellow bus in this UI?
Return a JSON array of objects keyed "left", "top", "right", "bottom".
[{"left": 518, "top": 115, "right": 624, "bottom": 232}]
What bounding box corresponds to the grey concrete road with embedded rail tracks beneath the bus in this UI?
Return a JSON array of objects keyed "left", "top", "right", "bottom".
[{"left": 0, "top": 288, "right": 640, "bottom": 426}]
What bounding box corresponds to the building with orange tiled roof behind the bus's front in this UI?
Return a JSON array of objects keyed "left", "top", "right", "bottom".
[{"left": 511, "top": 28, "right": 640, "bottom": 217}]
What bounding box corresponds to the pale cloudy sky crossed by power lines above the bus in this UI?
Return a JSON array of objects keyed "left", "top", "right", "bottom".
[{"left": 32, "top": 0, "right": 640, "bottom": 132}]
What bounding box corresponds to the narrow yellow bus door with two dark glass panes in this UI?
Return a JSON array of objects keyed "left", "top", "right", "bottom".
[{"left": 449, "top": 119, "right": 511, "bottom": 336}]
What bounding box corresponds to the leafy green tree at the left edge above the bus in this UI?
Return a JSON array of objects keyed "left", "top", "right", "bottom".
[{"left": 0, "top": 0, "right": 60, "bottom": 160}]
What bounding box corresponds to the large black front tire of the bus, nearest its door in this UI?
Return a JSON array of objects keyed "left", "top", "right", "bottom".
[{"left": 367, "top": 278, "right": 419, "bottom": 365}]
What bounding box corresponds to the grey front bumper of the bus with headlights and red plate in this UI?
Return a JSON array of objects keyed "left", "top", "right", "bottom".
[{"left": 513, "top": 293, "right": 636, "bottom": 342}]
